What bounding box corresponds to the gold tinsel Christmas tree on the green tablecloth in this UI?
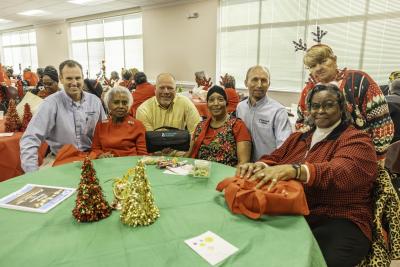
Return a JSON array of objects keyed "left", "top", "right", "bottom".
[{"left": 121, "top": 162, "right": 160, "bottom": 227}]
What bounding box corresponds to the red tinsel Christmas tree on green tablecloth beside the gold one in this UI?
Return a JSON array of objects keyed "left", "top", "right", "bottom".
[{"left": 72, "top": 157, "right": 111, "bottom": 222}]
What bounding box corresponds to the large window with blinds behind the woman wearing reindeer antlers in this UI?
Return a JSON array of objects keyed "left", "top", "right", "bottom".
[{"left": 217, "top": 0, "right": 400, "bottom": 92}]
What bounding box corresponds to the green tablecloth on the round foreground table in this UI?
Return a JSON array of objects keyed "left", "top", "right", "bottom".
[{"left": 0, "top": 157, "right": 326, "bottom": 267}]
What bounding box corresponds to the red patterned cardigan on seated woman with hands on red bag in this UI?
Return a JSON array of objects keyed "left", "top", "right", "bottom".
[{"left": 260, "top": 124, "right": 378, "bottom": 240}]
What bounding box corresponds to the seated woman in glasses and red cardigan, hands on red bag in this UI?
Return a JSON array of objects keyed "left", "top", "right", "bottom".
[{"left": 237, "top": 84, "right": 378, "bottom": 266}]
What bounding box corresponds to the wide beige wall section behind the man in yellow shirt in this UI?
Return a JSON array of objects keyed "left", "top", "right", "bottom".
[{"left": 143, "top": 0, "right": 218, "bottom": 81}]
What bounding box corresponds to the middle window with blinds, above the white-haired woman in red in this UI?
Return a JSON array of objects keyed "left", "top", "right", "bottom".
[{"left": 70, "top": 14, "right": 143, "bottom": 79}]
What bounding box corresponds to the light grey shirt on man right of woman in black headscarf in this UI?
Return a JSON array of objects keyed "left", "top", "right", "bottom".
[{"left": 236, "top": 96, "right": 292, "bottom": 162}]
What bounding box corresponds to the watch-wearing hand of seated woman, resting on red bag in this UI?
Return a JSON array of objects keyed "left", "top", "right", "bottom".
[{"left": 250, "top": 164, "right": 296, "bottom": 191}]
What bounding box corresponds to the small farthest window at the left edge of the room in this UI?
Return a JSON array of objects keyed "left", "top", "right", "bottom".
[{"left": 0, "top": 30, "right": 38, "bottom": 73}]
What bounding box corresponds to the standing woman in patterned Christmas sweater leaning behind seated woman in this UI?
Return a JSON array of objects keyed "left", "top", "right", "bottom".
[{"left": 296, "top": 44, "right": 393, "bottom": 160}]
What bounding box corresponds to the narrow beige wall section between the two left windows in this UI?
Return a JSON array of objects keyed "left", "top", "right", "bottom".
[{"left": 35, "top": 23, "right": 69, "bottom": 68}]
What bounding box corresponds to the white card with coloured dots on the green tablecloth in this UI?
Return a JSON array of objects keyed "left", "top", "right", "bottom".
[{"left": 185, "top": 231, "right": 239, "bottom": 265}]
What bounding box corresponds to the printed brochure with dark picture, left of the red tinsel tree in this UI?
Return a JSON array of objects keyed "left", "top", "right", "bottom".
[{"left": 0, "top": 184, "right": 75, "bottom": 213}]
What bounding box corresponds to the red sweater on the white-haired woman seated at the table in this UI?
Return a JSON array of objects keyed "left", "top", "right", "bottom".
[{"left": 90, "top": 116, "right": 147, "bottom": 158}]
